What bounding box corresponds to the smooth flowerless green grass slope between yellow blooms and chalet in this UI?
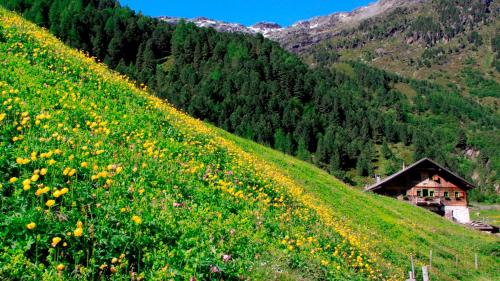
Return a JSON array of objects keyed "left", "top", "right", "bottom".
[{"left": 225, "top": 130, "right": 500, "bottom": 280}]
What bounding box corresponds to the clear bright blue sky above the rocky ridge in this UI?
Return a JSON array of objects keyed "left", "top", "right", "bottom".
[{"left": 120, "top": 0, "right": 375, "bottom": 26}]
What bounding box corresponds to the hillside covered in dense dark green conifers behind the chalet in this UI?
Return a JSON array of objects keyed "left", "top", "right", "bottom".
[{"left": 3, "top": 0, "right": 500, "bottom": 201}]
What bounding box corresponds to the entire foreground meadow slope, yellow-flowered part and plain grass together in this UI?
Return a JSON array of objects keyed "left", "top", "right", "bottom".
[{"left": 0, "top": 8, "right": 499, "bottom": 280}]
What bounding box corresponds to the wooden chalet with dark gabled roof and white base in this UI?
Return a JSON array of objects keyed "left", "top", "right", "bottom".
[{"left": 366, "top": 158, "right": 474, "bottom": 223}]
